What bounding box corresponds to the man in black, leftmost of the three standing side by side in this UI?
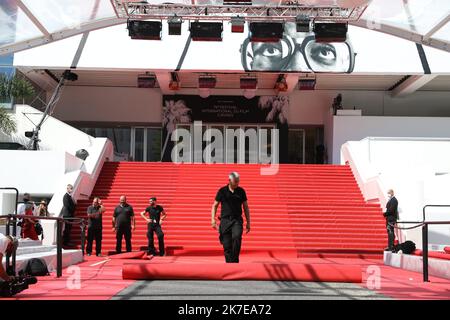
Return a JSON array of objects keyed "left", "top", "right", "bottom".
[{"left": 86, "top": 197, "right": 105, "bottom": 257}]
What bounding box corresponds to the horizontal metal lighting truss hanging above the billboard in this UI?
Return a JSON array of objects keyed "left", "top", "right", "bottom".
[{"left": 111, "top": 0, "right": 367, "bottom": 21}]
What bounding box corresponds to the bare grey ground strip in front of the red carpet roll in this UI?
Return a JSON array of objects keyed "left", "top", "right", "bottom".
[{"left": 112, "top": 280, "right": 389, "bottom": 300}]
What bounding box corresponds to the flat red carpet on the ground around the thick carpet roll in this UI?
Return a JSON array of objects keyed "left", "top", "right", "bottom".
[{"left": 8, "top": 255, "right": 450, "bottom": 300}]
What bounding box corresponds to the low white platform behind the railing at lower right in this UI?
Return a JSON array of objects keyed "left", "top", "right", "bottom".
[{"left": 384, "top": 252, "right": 450, "bottom": 279}]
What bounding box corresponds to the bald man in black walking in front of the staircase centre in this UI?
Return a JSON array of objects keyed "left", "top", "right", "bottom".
[{"left": 211, "top": 172, "right": 250, "bottom": 263}]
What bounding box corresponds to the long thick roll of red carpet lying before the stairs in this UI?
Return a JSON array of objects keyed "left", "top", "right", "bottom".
[{"left": 122, "top": 262, "right": 362, "bottom": 283}]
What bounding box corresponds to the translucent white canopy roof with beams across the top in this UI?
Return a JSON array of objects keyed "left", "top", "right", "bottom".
[{"left": 0, "top": 0, "right": 450, "bottom": 55}]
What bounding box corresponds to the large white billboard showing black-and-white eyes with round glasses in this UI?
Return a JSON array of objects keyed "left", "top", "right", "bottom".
[{"left": 15, "top": 21, "right": 436, "bottom": 75}]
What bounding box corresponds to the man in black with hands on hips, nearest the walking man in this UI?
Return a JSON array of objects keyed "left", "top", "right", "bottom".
[{"left": 141, "top": 197, "right": 166, "bottom": 256}]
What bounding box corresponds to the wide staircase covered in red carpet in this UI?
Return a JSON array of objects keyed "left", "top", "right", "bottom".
[{"left": 73, "top": 162, "right": 386, "bottom": 256}]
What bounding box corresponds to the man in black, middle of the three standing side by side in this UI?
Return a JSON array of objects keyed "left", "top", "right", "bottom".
[{"left": 113, "top": 196, "right": 136, "bottom": 253}]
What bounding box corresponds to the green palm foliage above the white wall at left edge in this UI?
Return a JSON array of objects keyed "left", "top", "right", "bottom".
[{"left": 0, "top": 74, "right": 35, "bottom": 134}]
